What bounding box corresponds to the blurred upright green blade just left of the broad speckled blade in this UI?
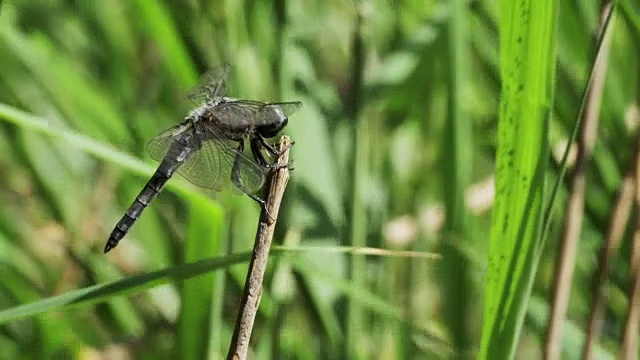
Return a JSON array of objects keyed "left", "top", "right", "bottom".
[{"left": 439, "top": 0, "right": 474, "bottom": 351}]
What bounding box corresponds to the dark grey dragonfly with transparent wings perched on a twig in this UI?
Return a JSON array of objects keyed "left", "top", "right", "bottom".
[{"left": 104, "top": 64, "right": 302, "bottom": 253}]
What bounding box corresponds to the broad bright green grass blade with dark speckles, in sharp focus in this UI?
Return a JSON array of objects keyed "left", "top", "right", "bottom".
[{"left": 478, "top": 0, "right": 558, "bottom": 359}]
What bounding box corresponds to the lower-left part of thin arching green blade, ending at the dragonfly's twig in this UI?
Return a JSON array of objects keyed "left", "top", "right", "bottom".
[{"left": 0, "top": 252, "right": 251, "bottom": 324}]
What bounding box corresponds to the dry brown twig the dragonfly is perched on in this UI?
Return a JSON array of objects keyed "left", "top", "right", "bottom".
[{"left": 227, "top": 136, "right": 291, "bottom": 360}]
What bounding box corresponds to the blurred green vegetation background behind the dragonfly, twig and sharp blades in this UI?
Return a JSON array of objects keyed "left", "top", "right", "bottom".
[{"left": 0, "top": 0, "right": 640, "bottom": 359}]
